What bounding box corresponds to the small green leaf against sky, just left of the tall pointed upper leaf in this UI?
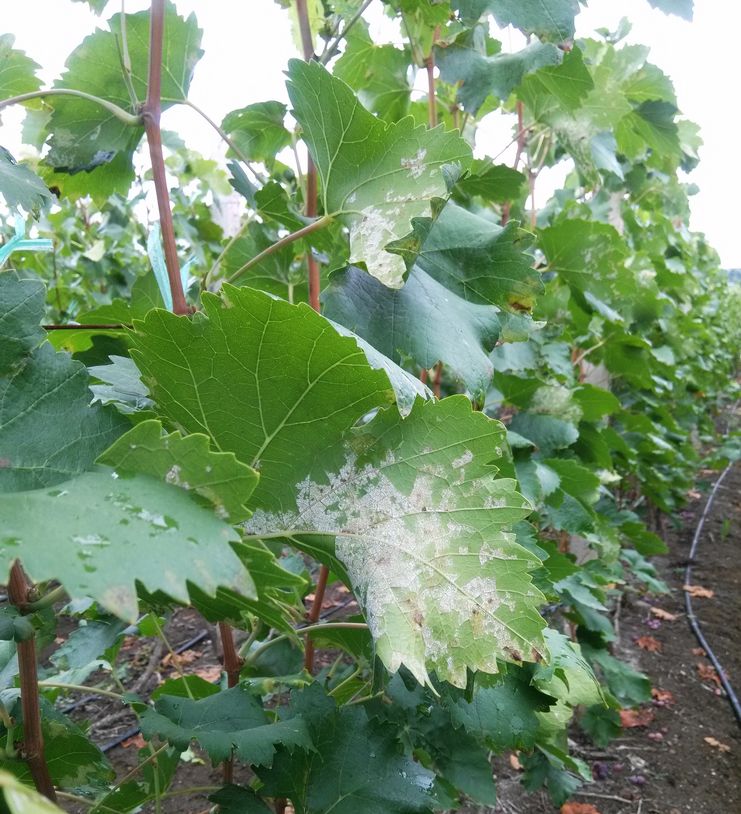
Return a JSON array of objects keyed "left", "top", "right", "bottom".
[{"left": 221, "top": 102, "right": 291, "bottom": 164}]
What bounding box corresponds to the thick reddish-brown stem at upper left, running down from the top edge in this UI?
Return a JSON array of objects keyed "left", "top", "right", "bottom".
[{"left": 142, "top": 0, "right": 189, "bottom": 314}]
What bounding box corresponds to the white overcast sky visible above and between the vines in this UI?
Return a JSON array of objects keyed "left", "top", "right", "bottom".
[{"left": 0, "top": 0, "right": 741, "bottom": 267}]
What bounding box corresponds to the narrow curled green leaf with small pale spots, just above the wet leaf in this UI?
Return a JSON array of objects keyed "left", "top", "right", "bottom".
[{"left": 98, "top": 420, "right": 258, "bottom": 524}]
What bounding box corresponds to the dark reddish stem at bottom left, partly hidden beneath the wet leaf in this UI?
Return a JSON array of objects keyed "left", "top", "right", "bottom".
[{"left": 8, "top": 560, "right": 57, "bottom": 802}]
